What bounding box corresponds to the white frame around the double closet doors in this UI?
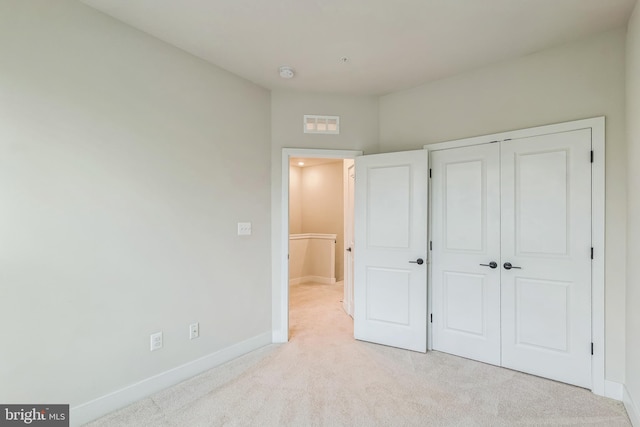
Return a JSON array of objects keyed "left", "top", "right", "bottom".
[{"left": 423, "top": 117, "right": 604, "bottom": 399}]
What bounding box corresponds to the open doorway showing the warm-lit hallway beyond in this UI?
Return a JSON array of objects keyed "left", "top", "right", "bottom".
[{"left": 289, "top": 157, "right": 346, "bottom": 339}]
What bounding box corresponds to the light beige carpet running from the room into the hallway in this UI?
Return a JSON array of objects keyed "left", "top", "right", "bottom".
[{"left": 90, "top": 284, "right": 631, "bottom": 427}]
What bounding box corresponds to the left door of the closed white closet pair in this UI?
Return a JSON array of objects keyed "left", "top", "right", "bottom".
[{"left": 431, "top": 143, "right": 502, "bottom": 365}]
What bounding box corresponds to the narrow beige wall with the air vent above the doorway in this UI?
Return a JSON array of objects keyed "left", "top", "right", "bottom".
[{"left": 271, "top": 91, "right": 378, "bottom": 337}]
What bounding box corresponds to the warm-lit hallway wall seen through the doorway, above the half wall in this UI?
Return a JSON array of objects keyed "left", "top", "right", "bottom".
[{"left": 289, "top": 161, "right": 344, "bottom": 281}]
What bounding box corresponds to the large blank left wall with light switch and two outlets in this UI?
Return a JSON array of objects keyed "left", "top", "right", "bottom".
[{"left": 0, "top": 0, "right": 271, "bottom": 406}]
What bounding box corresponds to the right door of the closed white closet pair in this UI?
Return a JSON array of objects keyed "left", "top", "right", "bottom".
[{"left": 500, "top": 129, "right": 591, "bottom": 387}]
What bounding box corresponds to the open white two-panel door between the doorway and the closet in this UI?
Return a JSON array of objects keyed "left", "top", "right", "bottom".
[{"left": 354, "top": 150, "right": 428, "bottom": 352}]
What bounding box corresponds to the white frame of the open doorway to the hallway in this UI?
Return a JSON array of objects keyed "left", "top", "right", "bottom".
[{"left": 272, "top": 148, "right": 363, "bottom": 343}]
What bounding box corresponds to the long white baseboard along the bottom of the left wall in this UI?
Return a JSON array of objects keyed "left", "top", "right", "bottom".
[{"left": 70, "top": 332, "right": 272, "bottom": 426}]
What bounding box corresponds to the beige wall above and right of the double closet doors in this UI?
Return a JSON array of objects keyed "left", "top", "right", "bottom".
[{"left": 380, "top": 29, "right": 626, "bottom": 382}]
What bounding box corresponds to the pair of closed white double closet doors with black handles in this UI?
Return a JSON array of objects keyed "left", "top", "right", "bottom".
[{"left": 430, "top": 129, "right": 592, "bottom": 388}]
